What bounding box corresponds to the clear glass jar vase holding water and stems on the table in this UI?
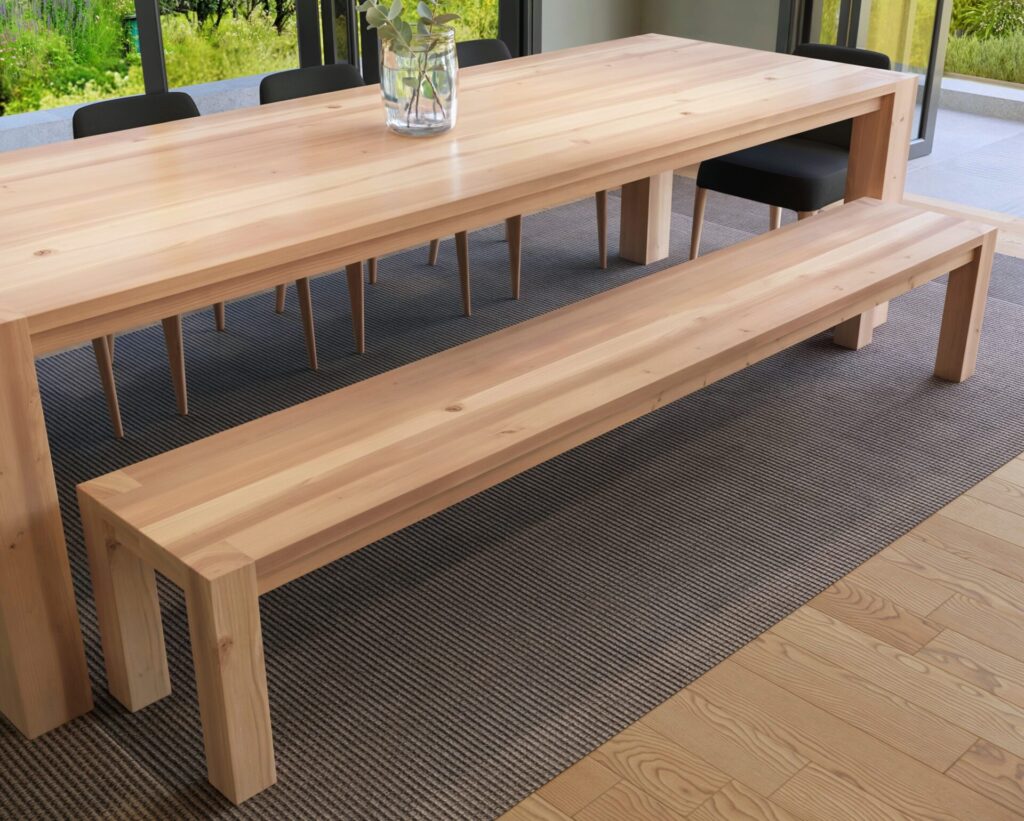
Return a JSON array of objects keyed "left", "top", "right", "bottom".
[{"left": 381, "top": 29, "right": 459, "bottom": 137}]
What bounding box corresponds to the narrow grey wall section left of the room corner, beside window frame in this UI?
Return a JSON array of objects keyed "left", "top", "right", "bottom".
[{"left": 541, "top": 0, "right": 644, "bottom": 51}]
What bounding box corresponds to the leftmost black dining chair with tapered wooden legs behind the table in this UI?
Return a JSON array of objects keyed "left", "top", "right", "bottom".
[{"left": 72, "top": 91, "right": 206, "bottom": 439}]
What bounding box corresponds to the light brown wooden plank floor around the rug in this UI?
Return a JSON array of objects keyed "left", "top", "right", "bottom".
[{"left": 505, "top": 198, "right": 1024, "bottom": 821}]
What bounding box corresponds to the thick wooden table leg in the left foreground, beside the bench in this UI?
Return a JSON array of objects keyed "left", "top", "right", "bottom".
[{"left": 0, "top": 315, "right": 92, "bottom": 738}]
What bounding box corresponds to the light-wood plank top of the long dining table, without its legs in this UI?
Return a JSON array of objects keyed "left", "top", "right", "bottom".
[{"left": 0, "top": 35, "right": 905, "bottom": 347}]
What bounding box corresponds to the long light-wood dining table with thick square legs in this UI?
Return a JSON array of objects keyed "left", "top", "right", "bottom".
[{"left": 0, "top": 35, "right": 916, "bottom": 737}]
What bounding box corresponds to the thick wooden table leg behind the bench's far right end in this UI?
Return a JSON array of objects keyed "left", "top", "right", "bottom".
[{"left": 834, "top": 77, "right": 918, "bottom": 350}]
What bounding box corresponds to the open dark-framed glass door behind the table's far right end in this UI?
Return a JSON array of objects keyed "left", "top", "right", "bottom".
[{"left": 794, "top": 0, "right": 952, "bottom": 157}]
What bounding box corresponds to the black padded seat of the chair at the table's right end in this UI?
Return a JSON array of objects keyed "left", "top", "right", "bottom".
[{"left": 697, "top": 137, "right": 849, "bottom": 211}]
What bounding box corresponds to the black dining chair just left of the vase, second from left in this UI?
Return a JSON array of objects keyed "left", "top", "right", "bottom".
[{"left": 259, "top": 62, "right": 377, "bottom": 358}]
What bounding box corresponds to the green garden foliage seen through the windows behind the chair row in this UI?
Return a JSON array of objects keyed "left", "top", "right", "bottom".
[{"left": 0, "top": 0, "right": 498, "bottom": 114}]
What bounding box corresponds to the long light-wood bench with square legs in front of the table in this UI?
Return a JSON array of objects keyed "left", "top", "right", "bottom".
[{"left": 79, "top": 200, "right": 995, "bottom": 803}]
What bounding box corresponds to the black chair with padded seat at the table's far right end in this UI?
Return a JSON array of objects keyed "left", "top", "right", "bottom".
[{"left": 690, "top": 43, "right": 892, "bottom": 259}]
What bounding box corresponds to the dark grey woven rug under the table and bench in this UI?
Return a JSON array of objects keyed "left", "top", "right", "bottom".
[{"left": 6, "top": 180, "right": 1024, "bottom": 820}]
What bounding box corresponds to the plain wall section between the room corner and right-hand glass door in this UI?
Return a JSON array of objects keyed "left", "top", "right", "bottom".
[{"left": 643, "top": 0, "right": 784, "bottom": 51}]
